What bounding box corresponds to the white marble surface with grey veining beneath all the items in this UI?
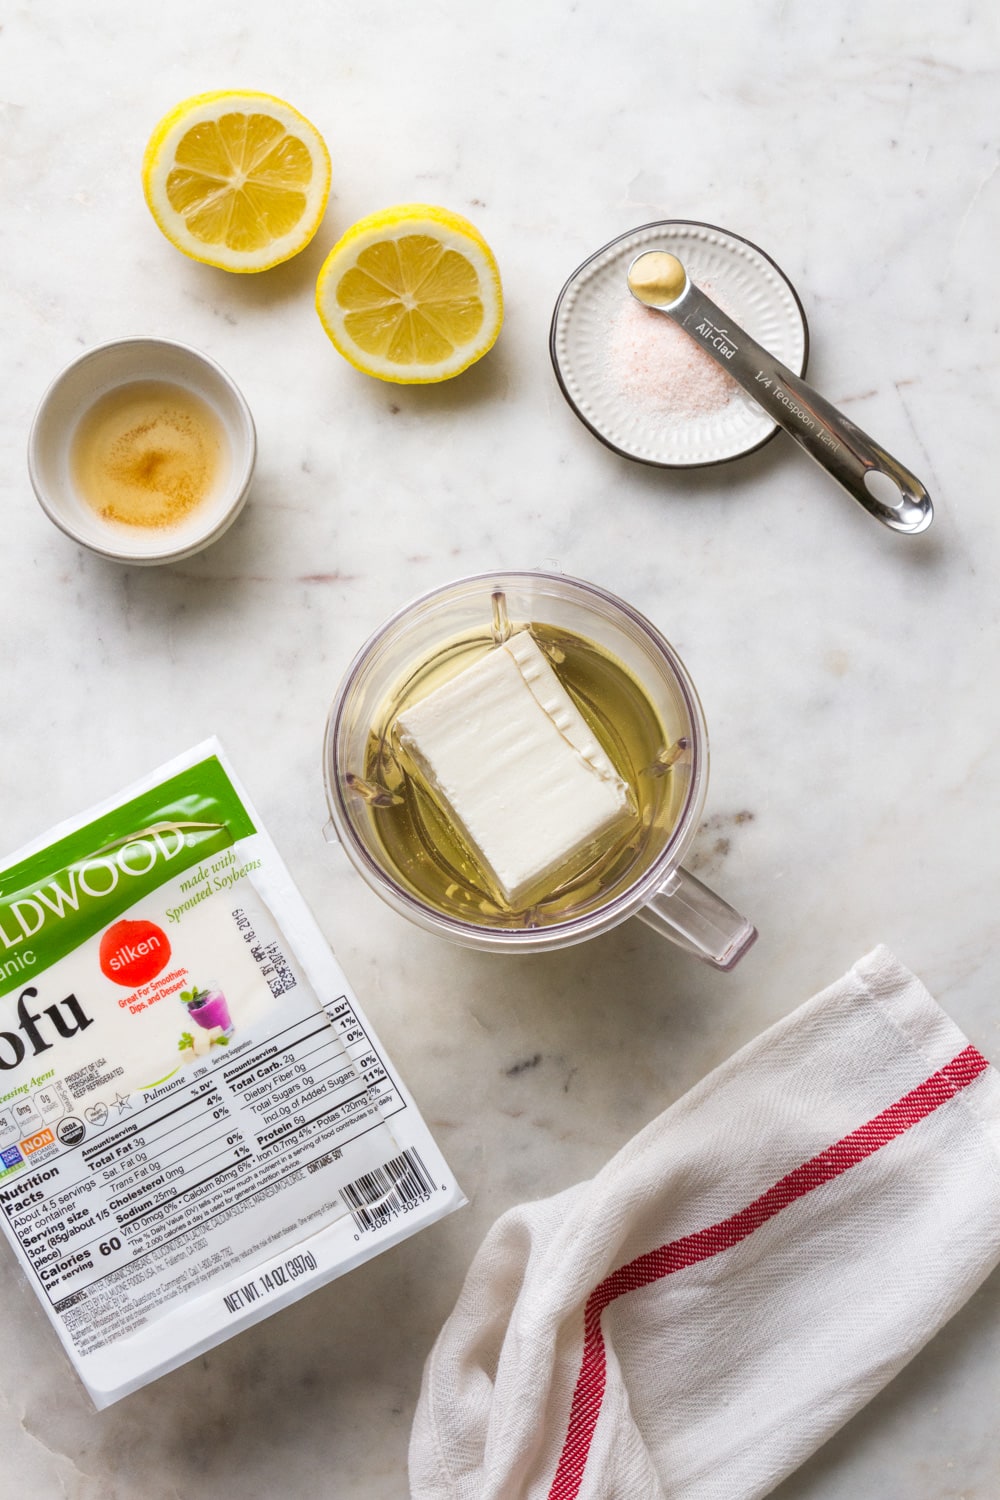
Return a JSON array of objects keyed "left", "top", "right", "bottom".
[{"left": 0, "top": 0, "right": 1000, "bottom": 1500}]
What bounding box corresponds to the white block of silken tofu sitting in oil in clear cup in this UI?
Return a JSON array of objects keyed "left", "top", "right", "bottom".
[{"left": 396, "top": 630, "right": 634, "bottom": 908}]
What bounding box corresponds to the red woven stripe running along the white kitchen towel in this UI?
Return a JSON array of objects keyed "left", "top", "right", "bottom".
[{"left": 549, "top": 1047, "right": 990, "bottom": 1500}]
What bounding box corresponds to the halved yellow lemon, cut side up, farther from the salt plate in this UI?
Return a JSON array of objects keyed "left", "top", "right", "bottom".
[{"left": 142, "top": 92, "right": 330, "bottom": 272}]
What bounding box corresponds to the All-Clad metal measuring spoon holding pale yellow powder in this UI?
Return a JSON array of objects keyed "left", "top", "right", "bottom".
[{"left": 628, "top": 251, "right": 934, "bottom": 534}]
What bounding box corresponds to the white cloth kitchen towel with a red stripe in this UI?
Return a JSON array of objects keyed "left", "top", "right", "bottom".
[{"left": 409, "top": 948, "right": 1000, "bottom": 1500}]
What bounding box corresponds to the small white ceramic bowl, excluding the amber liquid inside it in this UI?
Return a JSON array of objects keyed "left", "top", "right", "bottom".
[{"left": 28, "top": 338, "right": 256, "bottom": 564}]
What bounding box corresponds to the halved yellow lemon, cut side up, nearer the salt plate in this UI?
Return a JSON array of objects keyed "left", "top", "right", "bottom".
[{"left": 316, "top": 203, "right": 504, "bottom": 386}]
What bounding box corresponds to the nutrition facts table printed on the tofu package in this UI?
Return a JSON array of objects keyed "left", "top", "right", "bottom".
[{"left": 0, "top": 996, "right": 407, "bottom": 1353}]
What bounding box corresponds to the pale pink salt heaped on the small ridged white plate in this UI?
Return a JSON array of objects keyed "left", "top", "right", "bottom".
[{"left": 607, "top": 282, "right": 739, "bottom": 417}]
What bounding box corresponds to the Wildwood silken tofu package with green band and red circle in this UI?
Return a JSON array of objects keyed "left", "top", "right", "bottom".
[{"left": 0, "top": 741, "right": 465, "bottom": 1407}]
